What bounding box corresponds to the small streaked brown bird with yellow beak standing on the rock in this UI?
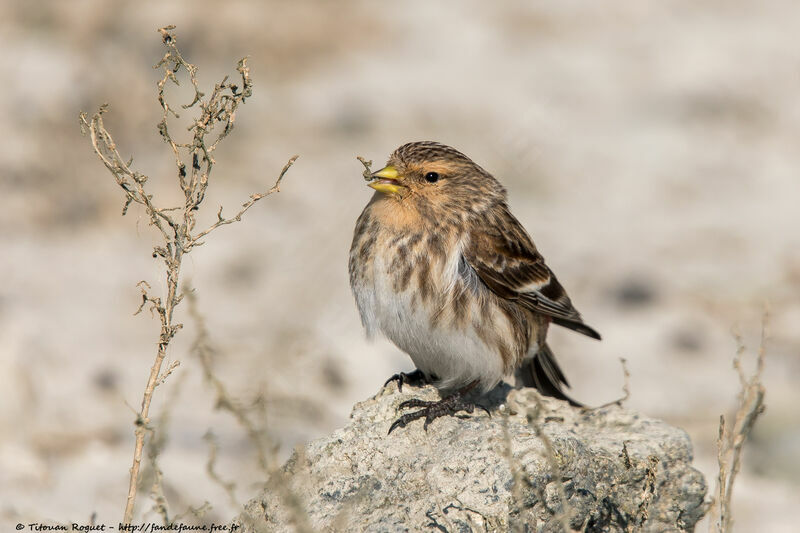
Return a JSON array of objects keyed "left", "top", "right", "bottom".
[{"left": 348, "top": 141, "right": 601, "bottom": 433}]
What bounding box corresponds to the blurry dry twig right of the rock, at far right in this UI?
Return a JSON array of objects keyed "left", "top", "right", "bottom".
[{"left": 709, "top": 312, "right": 769, "bottom": 533}]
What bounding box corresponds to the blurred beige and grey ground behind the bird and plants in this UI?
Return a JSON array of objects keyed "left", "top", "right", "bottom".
[{"left": 0, "top": 0, "right": 800, "bottom": 531}]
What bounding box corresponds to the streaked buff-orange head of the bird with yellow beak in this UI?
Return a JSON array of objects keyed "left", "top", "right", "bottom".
[{"left": 367, "top": 141, "right": 505, "bottom": 215}]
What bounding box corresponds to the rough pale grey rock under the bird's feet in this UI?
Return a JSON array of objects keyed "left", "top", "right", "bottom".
[{"left": 238, "top": 384, "right": 706, "bottom": 532}]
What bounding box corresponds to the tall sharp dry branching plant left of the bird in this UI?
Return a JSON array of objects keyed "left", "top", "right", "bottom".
[{"left": 80, "top": 26, "right": 297, "bottom": 524}]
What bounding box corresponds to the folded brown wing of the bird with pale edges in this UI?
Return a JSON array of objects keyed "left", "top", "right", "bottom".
[{"left": 464, "top": 206, "right": 600, "bottom": 339}]
